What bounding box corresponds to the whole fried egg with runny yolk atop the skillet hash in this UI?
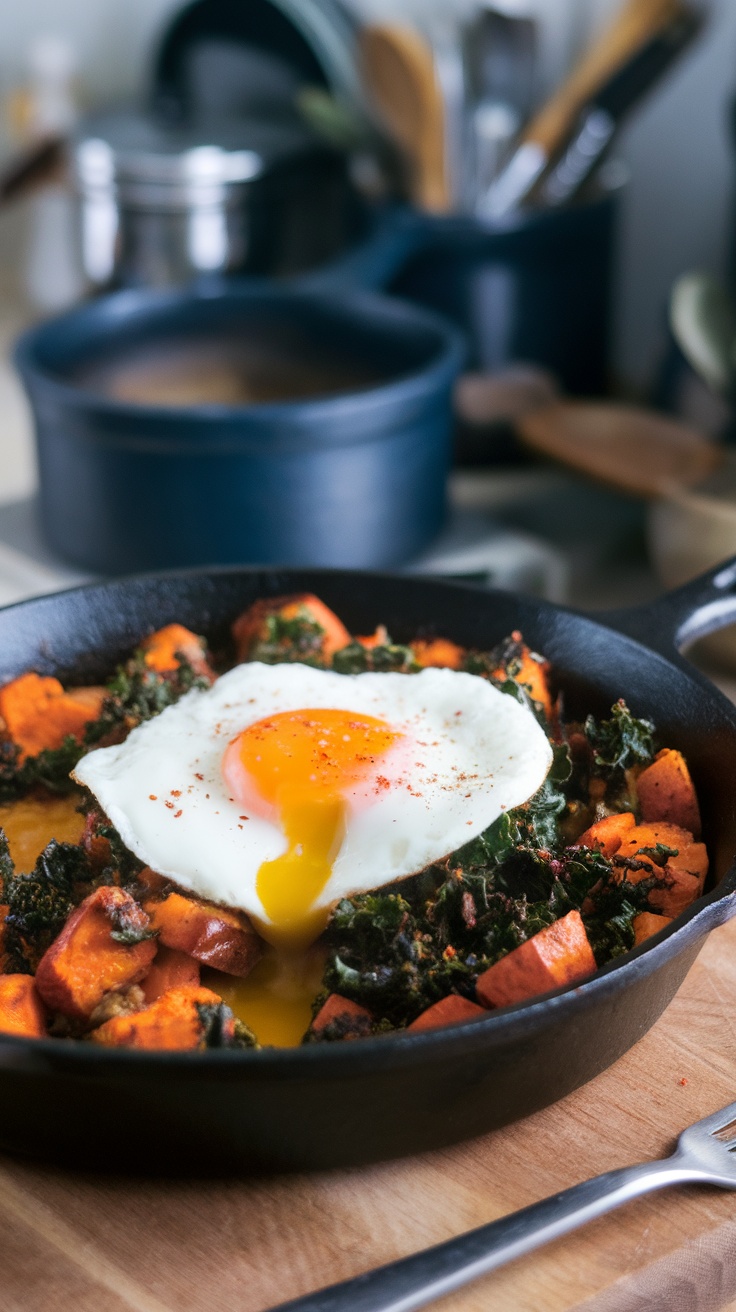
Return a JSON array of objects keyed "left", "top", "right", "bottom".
[{"left": 75, "top": 663, "right": 552, "bottom": 949}]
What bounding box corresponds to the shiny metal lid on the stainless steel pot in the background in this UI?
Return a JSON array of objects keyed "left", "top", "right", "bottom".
[{"left": 73, "top": 110, "right": 314, "bottom": 190}]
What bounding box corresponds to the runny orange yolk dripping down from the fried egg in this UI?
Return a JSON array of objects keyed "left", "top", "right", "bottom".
[{"left": 223, "top": 708, "right": 401, "bottom": 950}]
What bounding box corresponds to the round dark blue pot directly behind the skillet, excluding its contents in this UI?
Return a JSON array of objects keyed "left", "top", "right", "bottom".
[{"left": 16, "top": 282, "right": 463, "bottom": 573}]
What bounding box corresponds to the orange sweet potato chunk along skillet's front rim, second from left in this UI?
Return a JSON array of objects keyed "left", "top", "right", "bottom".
[{"left": 89, "top": 988, "right": 235, "bottom": 1050}]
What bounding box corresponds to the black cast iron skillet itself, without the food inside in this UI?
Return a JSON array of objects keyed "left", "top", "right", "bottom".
[{"left": 0, "top": 560, "right": 736, "bottom": 1173}]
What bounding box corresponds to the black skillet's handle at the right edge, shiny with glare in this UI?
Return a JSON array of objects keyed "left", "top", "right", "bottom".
[{"left": 600, "top": 556, "right": 736, "bottom": 659}]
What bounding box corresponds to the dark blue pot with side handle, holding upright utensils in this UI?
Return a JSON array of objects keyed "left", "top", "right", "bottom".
[{"left": 314, "top": 186, "right": 621, "bottom": 396}]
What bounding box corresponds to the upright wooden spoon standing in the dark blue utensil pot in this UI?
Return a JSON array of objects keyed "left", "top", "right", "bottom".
[{"left": 361, "top": 24, "right": 451, "bottom": 213}]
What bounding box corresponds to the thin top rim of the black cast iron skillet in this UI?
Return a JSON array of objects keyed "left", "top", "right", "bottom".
[{"left": 0, "top": 565, "right": 736, "bottom": 1078}]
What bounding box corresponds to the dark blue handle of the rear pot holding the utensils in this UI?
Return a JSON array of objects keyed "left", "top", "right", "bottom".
[{"left": 295, "top": 206, "right": 432, "bottom": 291}]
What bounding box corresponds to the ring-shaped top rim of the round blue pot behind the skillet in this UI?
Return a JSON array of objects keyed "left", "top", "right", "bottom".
[{"left": 13, "top": 279, "right": 467, "bottom": 426}]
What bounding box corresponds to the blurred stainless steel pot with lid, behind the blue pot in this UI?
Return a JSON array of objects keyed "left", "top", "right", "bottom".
[{"left": 72, "top": 112, "right": 352, "bottom": 290}]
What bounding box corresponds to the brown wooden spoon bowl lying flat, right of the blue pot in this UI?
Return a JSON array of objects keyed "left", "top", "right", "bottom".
[{"left": 517, "top": 401, "right": 724, "bottom": 497}]
